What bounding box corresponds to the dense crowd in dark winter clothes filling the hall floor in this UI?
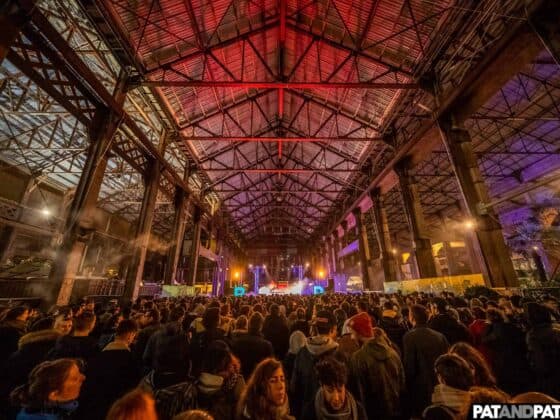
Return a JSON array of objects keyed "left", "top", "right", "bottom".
[{"left": 0, "top": 292, "right": 560, "bottom": 420}]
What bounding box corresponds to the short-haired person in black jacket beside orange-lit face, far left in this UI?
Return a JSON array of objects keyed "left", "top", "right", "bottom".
[{"left": 49, "top": 311, "right": 98, "bottom": 361}]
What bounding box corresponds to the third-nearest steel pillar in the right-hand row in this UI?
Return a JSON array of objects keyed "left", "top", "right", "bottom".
[{"left": 370, "top": 188, "right": 399, "bottom": 290}]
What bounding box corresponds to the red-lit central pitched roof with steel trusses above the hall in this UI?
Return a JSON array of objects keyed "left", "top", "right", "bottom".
[{"left": 81, "top": 0, "right": 532, "bottom": 241}]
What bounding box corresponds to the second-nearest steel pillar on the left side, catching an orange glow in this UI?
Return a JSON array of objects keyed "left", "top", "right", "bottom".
[{"left": 123, "top": 160, "right": 161, "bottom": 301}]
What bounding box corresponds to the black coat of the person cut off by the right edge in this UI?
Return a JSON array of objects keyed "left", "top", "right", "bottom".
[{"left": 527, "top": 324, "right": 560, "bottom": 399}]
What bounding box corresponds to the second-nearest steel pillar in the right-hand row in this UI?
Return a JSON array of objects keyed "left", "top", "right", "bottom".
[{"left": 394, "top": 159, "right": 437, "bottom": 278}]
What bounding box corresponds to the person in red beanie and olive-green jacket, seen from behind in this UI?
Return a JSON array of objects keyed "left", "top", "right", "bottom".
[{"left": 348, "top": 312, "right": 405, "bottom": 419}]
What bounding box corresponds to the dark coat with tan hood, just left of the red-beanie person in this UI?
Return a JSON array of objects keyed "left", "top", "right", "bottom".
[{"left": 290, "top": 335, "right": 338, "bottom": 417}]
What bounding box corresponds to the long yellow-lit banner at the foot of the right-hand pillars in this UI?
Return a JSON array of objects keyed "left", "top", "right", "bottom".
[{"left": 384, "top": 274, "right": 486, "bottom": 294}]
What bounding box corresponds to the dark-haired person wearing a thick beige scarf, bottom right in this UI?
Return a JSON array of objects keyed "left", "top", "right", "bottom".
[{"left": 422, "top": 354, "right": 474, "bottom": 420}]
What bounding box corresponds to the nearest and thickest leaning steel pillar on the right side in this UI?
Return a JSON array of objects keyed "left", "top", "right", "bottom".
[{"left": 438, "top": 115, "right": 518, "bottom": 287}]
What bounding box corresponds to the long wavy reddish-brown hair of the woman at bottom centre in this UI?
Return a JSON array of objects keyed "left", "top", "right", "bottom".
[{"left": 237, "top": 357, "right": 288, "bottom": 419}]
